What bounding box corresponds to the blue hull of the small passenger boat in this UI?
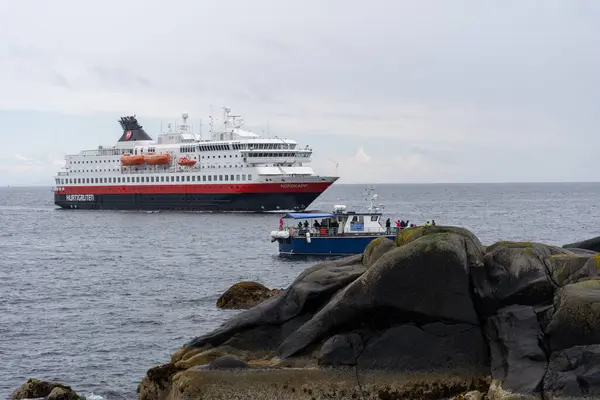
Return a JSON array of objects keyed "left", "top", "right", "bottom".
[{"left": 277, "top": 235, "right": 396, "bottom": 256}]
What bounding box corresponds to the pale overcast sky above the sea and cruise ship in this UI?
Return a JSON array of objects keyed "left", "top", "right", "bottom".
[{"left": 0, "top": 0, "right": 600, "bottom": 185}]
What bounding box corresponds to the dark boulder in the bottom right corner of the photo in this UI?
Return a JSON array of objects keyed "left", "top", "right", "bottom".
[{"left": 544, "top": 345, "right": 600, "bottom": 400}]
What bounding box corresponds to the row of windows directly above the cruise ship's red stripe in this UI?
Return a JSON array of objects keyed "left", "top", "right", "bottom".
[{"left": 56, "top": 174, "right": 252, "bottom": 185}]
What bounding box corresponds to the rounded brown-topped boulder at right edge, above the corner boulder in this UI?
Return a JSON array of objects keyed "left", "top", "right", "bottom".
[{"left": 545, "top": 279, "right": 600, "bottom": 351}]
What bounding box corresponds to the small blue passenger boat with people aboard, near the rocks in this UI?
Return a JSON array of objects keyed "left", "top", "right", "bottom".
[{"left": 271, "top": 188, "right": 396, "bottom": 256}]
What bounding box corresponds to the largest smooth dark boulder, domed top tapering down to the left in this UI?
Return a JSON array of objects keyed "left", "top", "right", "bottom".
[{"left": 278, "top": 232, "right": 483, "bottom": 358}]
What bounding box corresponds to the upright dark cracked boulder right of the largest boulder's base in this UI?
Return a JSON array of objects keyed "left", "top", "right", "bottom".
[{"left": 486, "top": 305, "right": 547, "bottom": 396}]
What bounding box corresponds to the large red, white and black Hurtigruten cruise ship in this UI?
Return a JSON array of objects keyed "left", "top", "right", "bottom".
[{"left": 53, "top": 108, "right": 338, "bottom": 212}]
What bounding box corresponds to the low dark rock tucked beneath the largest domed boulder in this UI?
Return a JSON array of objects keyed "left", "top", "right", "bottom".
[{"left": 357, "top": 322, "right": 489, "bottom": 371}]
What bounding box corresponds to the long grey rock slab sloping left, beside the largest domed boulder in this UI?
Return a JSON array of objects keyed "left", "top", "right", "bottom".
[{"left": 185, "top": 254, "right": 366, "bottom": 347}]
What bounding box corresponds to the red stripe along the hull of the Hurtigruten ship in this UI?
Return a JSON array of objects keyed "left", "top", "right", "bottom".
[{"left": 56, "top": 182, "right": 333, "bottom": 194}]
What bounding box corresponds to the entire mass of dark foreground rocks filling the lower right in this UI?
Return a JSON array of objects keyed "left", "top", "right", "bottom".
[{"left": 138, "top": 226, "right": 600, "bottom": 400}]
